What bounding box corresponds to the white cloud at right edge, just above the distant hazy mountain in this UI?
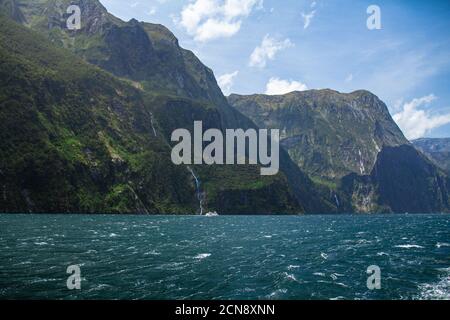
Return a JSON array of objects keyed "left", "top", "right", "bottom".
[{"left": 393, "top": 94, "right": 450, "bottom": 140}]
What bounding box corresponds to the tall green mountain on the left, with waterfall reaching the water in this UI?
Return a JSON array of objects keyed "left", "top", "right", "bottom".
[{"left": 0, "top": 0, "right": 333, "bottom": 214}]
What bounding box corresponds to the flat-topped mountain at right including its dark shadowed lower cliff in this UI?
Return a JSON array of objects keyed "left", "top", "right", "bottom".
[{"left": 228, "top": 90, "right": 449, "bottom": 213}]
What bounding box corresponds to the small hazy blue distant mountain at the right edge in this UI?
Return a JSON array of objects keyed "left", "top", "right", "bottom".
[{"left": 412, "top": 138, "right": 450, "bottom": 173}]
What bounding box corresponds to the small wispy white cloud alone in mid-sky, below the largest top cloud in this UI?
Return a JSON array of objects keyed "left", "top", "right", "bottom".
[{"left": 249, "top": 35, "right": 293, "bottom": 68}]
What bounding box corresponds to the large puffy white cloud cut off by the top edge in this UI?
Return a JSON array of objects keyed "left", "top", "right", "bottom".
[{"left": 177, "top": 0, "right": 263, "bottom": 42}]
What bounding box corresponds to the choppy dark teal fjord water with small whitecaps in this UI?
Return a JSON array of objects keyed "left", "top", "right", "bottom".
[{"left": 0, "top": 215, "right": 450, "bottom": 299}]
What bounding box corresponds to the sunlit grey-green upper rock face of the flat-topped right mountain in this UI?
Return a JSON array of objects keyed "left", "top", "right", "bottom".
[{"left": 229, "top": 90, "right": 408, "bottom": 181}]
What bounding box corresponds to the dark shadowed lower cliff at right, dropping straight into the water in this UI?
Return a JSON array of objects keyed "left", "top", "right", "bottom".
[{"left": 341, "top": 145, "right": 450, "bottom": 213}]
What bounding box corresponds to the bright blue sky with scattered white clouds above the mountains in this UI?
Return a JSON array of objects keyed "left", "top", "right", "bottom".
[{"left": 100, "top": 0, "right": 450, "bottom": 139}]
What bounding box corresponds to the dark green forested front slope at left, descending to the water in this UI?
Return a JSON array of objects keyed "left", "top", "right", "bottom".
[{"left": 0, "top": 17, "right": 198, "bottom": 213}]
